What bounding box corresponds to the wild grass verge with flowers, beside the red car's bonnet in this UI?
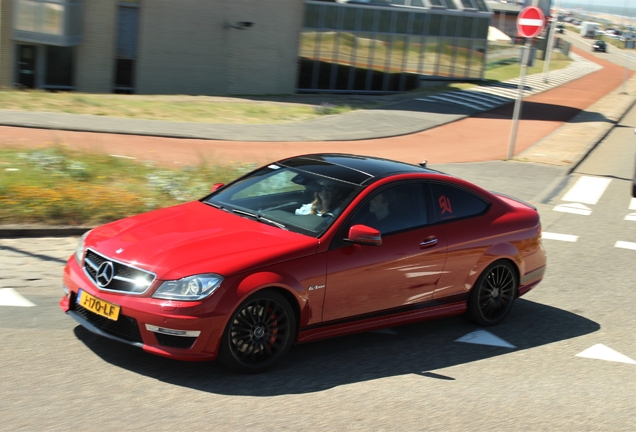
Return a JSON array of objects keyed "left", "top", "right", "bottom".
[{"left": 0, "top": 146, "right": 254, "bottom": 226}]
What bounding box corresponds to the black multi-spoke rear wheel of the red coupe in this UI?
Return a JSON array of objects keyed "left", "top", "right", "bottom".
[{"left": 466, "top": 260, "right": 519, "bottom": 327}]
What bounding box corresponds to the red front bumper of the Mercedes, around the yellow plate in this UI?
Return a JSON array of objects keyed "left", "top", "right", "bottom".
[{"left": 60, "top": 257, "right": 226, "bottom": 361}]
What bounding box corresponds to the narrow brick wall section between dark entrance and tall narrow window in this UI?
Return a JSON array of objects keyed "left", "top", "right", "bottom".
[{"left": 75, "top": 0, "right": 117, "bottom": 93}]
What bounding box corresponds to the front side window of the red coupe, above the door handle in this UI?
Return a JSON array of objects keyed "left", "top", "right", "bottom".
[{"left": 347, "top": 183, "right": 427, "bottom": 235}]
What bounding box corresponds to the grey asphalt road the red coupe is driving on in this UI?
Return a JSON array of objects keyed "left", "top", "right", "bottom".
[{"left": 0, "top": 117, "right": 636, "bottom": 431}]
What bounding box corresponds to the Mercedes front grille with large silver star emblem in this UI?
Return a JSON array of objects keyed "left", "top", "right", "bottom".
[{"left": 84, "top": 249, "right": 156, "bottom": 294}]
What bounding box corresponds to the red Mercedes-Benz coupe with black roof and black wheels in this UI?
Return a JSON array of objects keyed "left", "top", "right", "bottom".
[{"left": 60, "top": 154, "right": 546, "bottom": 372}]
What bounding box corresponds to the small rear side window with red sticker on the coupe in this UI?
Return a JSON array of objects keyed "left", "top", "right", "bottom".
[{"left": 431, "top": 183, "right": 488, "bottom": 221}]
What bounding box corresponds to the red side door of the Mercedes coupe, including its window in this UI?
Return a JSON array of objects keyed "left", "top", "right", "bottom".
[{"left": 323, "top": 182, "right": 446, "bottom": 321}]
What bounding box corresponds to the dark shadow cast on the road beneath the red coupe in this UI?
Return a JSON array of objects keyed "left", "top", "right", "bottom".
[{"left": 75, "top": 299, "right": 600, "bottom": 397}]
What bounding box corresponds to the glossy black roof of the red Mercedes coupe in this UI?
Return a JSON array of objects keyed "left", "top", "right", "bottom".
[{"left": 278, "top": 153, "right": 443, "bottom": 186}]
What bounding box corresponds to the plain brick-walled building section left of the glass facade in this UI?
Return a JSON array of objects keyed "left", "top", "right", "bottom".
[{"left": 0, "top": 0, "right": 304, "bottom": 95}]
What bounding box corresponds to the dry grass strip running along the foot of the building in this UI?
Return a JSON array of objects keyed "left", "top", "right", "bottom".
[{"left": 0, "top": 52, "right": 570, "bottom": 124}]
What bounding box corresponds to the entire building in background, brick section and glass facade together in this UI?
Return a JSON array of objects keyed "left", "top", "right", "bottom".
[{"left": 0, "top": 0, "right": 492, "bottom": 95}]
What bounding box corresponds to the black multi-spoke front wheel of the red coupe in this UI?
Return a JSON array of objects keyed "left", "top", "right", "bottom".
[{"left": 219, "top": 290, "right": 296, "bottom": 373}]
